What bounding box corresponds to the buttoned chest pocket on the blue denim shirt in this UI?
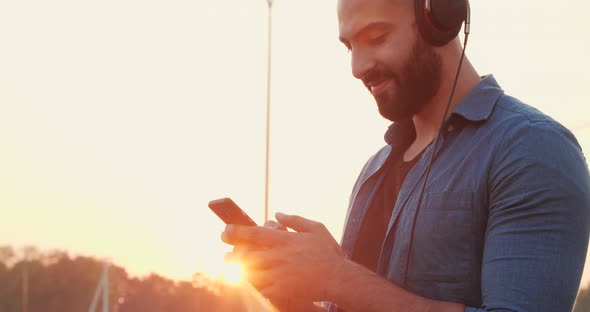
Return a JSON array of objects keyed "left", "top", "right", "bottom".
[{"left": 408, "top": 192, "right": 474, "bottom": 282}]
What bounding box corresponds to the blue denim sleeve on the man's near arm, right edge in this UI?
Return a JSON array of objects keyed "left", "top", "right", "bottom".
[{"left": 465, "top": 121, "right": 590, "bottom": 312}]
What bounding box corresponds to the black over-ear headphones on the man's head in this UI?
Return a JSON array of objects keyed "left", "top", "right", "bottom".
[{"left": 416, "top": 0, "right": 470, "bottom": 47}]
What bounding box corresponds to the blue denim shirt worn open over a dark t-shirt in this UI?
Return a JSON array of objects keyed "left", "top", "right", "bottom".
[{"left": 342, "top": 76, "right": 590, "bottom": 312}]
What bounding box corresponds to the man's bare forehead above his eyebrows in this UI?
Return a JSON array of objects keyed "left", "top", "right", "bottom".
[{"left": 338, "top": 0, "right": 414, "bottom": 37}]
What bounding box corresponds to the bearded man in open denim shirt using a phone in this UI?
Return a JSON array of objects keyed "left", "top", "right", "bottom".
[{"left": 222, "top": 0, "right": 590, "bottom": 311}]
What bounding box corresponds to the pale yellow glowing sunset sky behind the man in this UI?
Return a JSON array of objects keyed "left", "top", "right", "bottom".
[{"left": 0, "top": 0, "right": 590, "bottom": 285}]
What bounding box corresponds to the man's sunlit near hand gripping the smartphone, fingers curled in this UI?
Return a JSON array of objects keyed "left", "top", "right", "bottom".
[{"left": 222, "top": 213, "right": 346, "bottom": 302}]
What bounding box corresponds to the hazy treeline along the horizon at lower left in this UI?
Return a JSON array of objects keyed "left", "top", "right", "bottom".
[{"left": 0, "top": 246, "right": 272, "bottom": 312}]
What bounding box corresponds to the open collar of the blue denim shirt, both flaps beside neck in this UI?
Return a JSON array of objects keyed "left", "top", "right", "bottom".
[{"left": 385, "top": 75, "right": 504, "bottom": 148}]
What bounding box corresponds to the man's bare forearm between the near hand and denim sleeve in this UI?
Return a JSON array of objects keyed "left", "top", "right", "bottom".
[{"left": 326, "top": 260, "right": 465, "bottom": 312}]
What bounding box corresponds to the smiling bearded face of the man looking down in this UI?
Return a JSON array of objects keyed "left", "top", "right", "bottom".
[{"left": 338, "top": 0, "right": 441, "bottom": 121}]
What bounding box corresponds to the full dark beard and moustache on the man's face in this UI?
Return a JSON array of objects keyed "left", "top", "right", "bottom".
[{"left": 367, "top": 36, "right": 442, "bottom": 122}]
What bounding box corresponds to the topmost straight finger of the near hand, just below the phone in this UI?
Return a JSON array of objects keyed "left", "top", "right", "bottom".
[{"left": 221, "top": 224, "right": 293, "bottom": 246}]
